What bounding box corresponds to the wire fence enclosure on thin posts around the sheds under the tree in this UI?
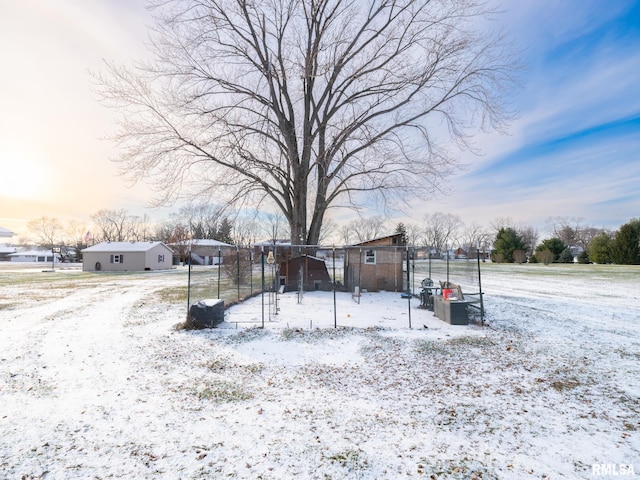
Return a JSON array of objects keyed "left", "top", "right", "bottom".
[{"left": 188, "top": 242, "right": 484, "bottom": 326}]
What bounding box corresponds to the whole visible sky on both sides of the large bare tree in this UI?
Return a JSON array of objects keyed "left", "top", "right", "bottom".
[{"left": 0, "top": 0, "right": 640, "bottom": 237}]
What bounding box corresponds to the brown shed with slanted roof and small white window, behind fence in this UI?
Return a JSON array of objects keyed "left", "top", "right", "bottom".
[{"left": 344, "top": 233, "right": 405, "bottom": 292}]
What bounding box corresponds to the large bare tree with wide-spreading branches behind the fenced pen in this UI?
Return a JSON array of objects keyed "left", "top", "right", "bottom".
[{"left": 96, "top": 0, "right": 512, "bottom": 244}]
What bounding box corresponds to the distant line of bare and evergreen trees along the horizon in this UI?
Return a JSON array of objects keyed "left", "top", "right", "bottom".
[{"left": 21, "top": 207, "right": 640, "bottom": 265}]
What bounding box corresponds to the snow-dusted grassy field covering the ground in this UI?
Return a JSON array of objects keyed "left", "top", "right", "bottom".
[{"left": 0, "top": 264, "right": 640, "bottom": 480}]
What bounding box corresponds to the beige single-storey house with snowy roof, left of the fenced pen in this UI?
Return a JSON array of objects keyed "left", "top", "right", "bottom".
[{"left": 82, "top": 242, "right": 173, "bottom": 272}]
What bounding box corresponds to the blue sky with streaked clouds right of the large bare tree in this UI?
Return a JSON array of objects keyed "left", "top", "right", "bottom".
[{"left": 440, "top": 0, "right": 640, "bottom": 231}]
